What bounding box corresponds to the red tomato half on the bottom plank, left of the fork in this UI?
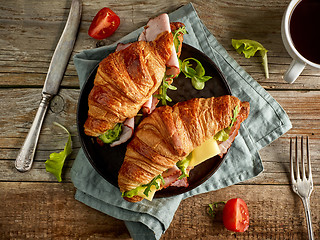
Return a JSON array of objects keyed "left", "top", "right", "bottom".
[{"left": 222, "top": 198, "right": 249, "bottom": 232}]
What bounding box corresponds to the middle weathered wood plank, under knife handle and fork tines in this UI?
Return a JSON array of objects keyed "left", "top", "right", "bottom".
[{"left": 0, "top": 89, "right": 320, "bottom": 184}]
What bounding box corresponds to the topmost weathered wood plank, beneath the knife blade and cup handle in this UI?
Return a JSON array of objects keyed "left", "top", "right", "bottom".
[{"left": 0, "top": 0, "right": 320, "bottom": 89}]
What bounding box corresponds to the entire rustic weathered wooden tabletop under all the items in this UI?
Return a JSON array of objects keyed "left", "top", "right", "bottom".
[{"left": 0, "top": 0, "right": 320, "bottom": 239}]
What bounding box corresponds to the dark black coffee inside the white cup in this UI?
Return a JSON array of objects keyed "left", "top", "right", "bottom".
[{"left": 290, "top": 0, "right": 320, "bottom": 64}]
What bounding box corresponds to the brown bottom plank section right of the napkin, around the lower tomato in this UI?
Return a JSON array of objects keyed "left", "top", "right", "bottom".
[{"left": 163, "top": 185, "right": 320, "bottom": 239}]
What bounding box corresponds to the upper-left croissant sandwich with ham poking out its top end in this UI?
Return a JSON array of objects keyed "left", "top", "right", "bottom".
[{"left": 84, "top": 14, "right": 184, "bottom": 147}]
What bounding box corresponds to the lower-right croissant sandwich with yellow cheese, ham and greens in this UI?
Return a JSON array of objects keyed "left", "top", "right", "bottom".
[{"left": 118, "top": 95, "right": 250, "bottom": 202}]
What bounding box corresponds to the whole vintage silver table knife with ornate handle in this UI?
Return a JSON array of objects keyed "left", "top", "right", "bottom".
[{"left": 15, "top": 0, "right": 82, "bottom": 172}]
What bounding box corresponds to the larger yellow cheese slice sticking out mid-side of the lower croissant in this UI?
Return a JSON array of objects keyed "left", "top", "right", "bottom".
[{"left": 189, "top": 138, "right": 220, "bottom": 166}]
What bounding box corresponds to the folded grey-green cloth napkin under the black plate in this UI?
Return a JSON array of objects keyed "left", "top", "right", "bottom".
[{"left": 71, "top": 3, "right": 291, "bottom": 240}]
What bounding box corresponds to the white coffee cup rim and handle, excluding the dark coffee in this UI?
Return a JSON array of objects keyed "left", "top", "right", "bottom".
[{"left": 281, "top": 0, "right": 320, "bottom": 83}]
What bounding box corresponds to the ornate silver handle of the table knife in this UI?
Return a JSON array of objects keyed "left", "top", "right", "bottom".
[{"left": 15, "top": 93, "right": 52, "bottom": 172}]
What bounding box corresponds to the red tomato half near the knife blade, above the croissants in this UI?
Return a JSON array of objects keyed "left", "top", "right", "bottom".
[{"left": 88, "top": 8, "right": 120, "bottom": 40}]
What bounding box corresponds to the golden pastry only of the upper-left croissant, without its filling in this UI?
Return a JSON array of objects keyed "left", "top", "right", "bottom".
[{"left": 84, "top": 31, "right": 173, "bottom": 137}]
